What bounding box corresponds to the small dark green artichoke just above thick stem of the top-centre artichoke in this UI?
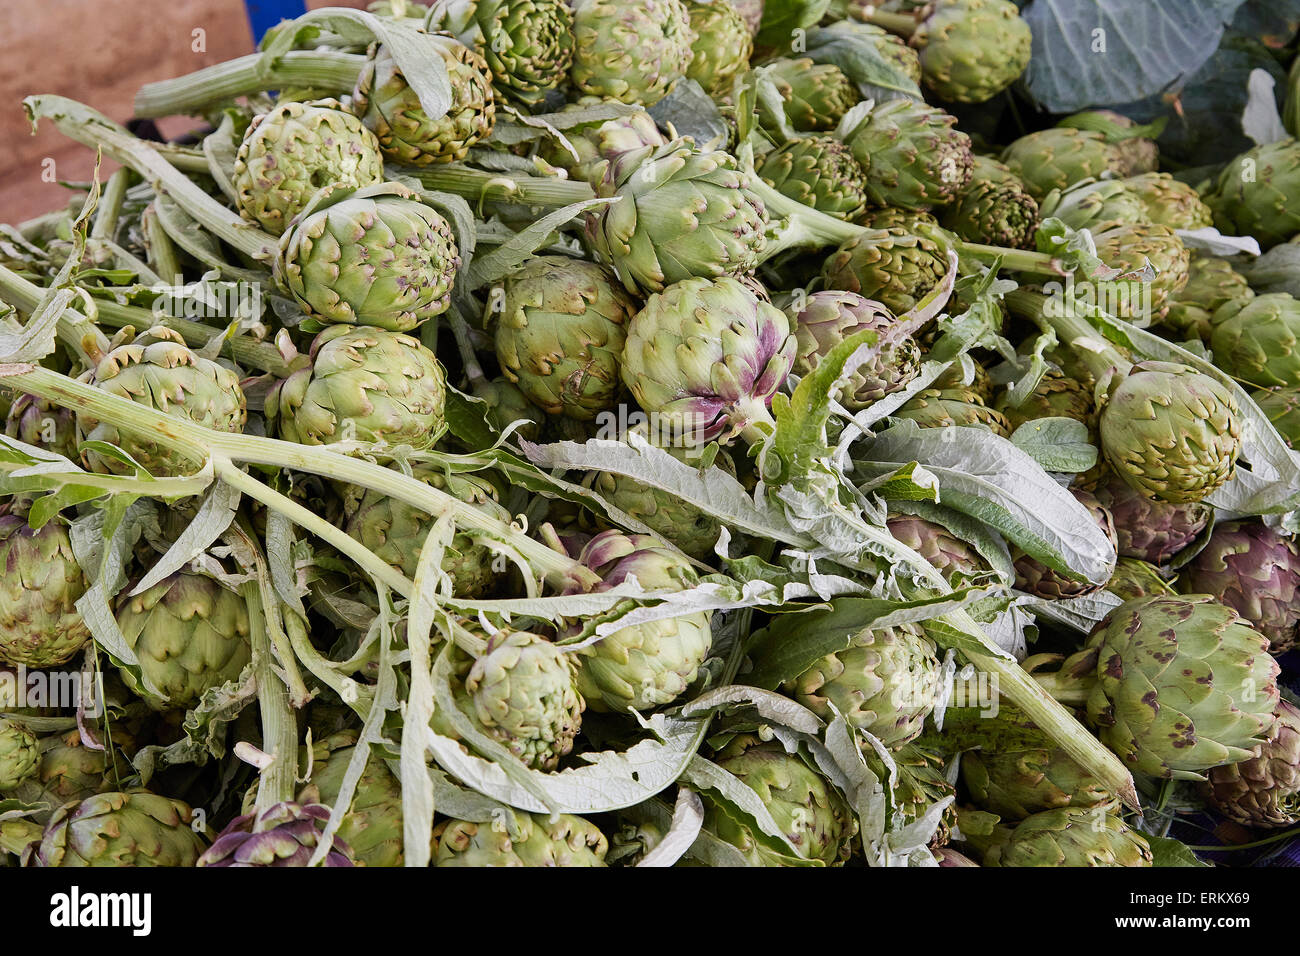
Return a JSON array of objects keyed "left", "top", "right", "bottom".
[{"left": 758, "top": 137, "right": 867, "bottom": 222}]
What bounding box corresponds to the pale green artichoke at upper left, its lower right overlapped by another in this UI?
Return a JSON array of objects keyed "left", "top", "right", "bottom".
[{"left": 231, "top": 100, "right": 384, "bottom": 235}]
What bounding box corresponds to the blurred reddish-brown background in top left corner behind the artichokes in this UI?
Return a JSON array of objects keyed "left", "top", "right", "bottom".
[{"left": 0, "top": 0, "right": 367, "bottom": 222}]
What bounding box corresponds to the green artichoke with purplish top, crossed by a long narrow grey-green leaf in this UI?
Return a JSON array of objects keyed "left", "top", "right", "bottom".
[{"left": 568, "top": 531, "right": 712, "bottom": 713}]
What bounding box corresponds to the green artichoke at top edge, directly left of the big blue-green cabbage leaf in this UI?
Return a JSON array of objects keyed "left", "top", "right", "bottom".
[{"left": 911, "top": 0, "right": 1032, "bottom": 103}]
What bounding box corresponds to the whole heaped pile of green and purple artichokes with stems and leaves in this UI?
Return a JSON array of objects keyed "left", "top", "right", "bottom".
[{"left": 0, "top": 0, "right": 1300, "bottom": 868}]
